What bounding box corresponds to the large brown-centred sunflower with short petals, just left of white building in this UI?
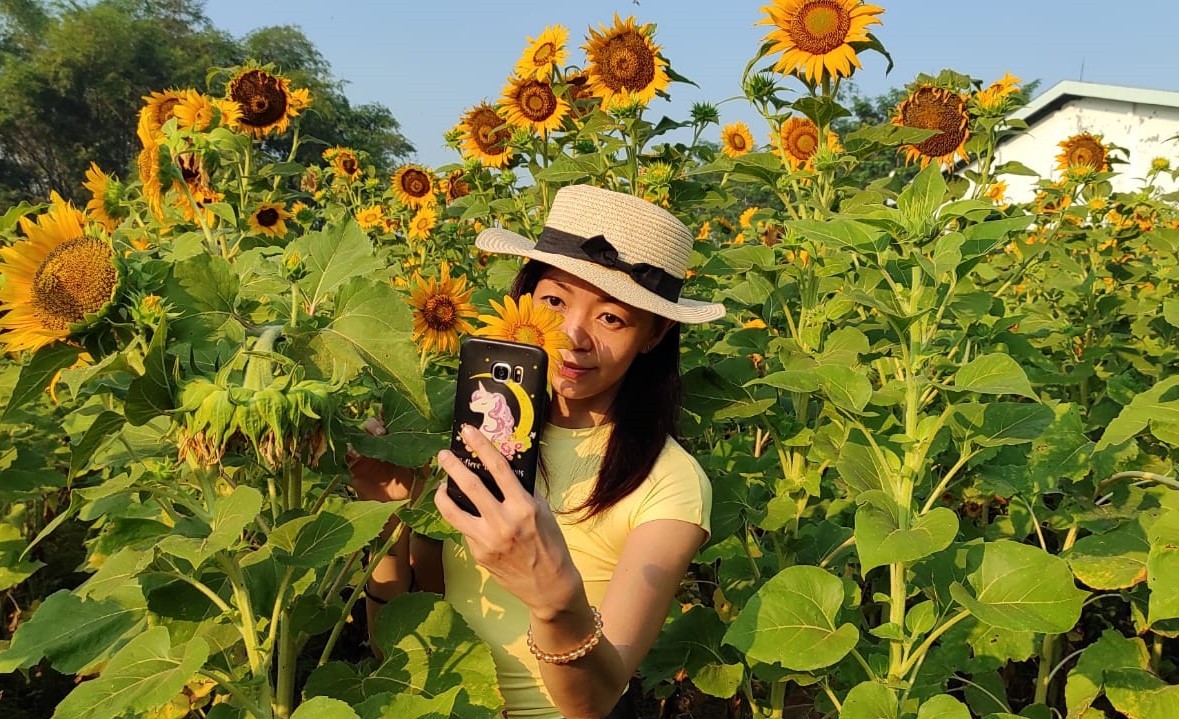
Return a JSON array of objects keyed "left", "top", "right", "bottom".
[{"left": 893, "top": 85, "right": 970, "bottom": 169}]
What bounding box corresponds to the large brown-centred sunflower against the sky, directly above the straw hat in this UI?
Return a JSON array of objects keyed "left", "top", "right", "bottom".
[{"left": 584, "top": 13, "right": 671, "bottom": 110}]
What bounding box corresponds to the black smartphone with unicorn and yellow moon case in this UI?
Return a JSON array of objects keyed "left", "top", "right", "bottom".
[{"left": 447, "top": 337, "right": 548, "bottom": 516}]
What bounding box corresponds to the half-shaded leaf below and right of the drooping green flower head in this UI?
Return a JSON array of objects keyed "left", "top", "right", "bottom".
[{"left": 270, "top": 502, "right": 396, "bottom": 568}]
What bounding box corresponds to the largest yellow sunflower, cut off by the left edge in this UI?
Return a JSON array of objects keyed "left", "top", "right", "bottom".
[{"left": 0, "top": 192, "right": 119, "bottom": 352}]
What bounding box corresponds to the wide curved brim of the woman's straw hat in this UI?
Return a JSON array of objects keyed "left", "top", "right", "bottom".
[{"left": 475, "top": 227, "right": 725, "bottom": 324}]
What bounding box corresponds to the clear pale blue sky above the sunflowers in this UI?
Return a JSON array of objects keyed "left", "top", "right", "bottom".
[{"left": 205, "top": 0, "right": 1179, "bottom": 166}]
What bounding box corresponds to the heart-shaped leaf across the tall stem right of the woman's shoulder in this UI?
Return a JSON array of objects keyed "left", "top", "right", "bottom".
[{"left": 856, "top": 493, "right": 959, "bottom": 574}]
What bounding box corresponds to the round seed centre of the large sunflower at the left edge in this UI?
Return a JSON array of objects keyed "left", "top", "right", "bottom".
[{"left": 32, "top": 237, "right": 118, "bottom": 330}]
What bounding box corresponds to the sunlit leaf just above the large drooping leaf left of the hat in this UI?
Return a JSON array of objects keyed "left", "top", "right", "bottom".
[{"left": 288, "top": 216, "right": 384, "bottom": 309}]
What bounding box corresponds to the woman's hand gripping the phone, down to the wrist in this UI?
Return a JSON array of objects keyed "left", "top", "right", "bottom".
[{"left": 434, "top": 424, "right": 585, "bottom": 620}]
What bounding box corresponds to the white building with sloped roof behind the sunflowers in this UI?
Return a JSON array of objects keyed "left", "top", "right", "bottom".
[{"left": 966, "top": 80, "right": 1179, "bottom": 202}]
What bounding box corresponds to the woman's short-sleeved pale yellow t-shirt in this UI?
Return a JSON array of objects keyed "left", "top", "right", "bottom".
[{"left": 442, "top": 424, "right": 712, "bottom": 719}]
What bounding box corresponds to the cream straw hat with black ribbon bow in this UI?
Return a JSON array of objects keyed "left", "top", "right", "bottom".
[{"left": 475, "top": 185, "right": 725, "bottom": 324}]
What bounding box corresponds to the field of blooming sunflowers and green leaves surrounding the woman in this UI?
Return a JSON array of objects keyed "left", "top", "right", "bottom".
[{"left": 0, "top": 0, "right": 1179, "bottom": 719}]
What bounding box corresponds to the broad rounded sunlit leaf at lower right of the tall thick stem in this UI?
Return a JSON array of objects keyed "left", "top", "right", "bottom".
[{"left": 950, "top": 540, "right": 1088, "bottom": 634}]
